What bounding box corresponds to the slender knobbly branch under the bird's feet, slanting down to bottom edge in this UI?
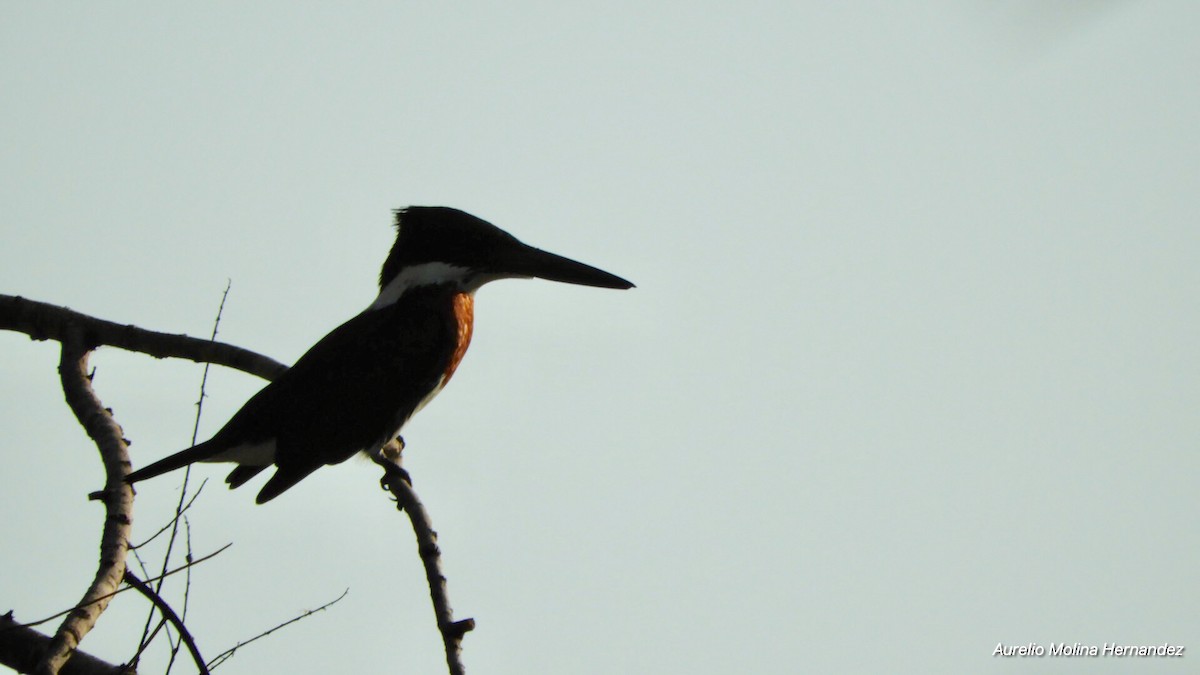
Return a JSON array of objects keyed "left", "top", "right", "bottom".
[{"left": 372, "top": 438, "right": 475, "bottom": 675}]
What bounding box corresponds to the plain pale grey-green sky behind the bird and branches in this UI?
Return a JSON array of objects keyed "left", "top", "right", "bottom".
[{"left": 0, "top": 0, "right": 1200, "bottom": 675}]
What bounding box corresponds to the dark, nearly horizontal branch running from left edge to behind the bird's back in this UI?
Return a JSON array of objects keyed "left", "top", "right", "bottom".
[{"left": 0, "top": 294, "right": 288, "bottom": 380}]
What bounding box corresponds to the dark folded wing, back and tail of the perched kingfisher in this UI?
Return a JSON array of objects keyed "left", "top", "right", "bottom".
[{"left": 128, "top": 287, "right": 458, "bottom": 503}]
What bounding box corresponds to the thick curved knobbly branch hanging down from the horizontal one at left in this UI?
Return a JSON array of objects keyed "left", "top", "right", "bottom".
[{"left": 36, "top": 324, "right": 133, "bottom": 675}]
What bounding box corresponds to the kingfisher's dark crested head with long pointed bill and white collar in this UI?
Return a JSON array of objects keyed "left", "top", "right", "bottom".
[{"left": 377, "top": 207, "right": 634, "bottom": 304}]
